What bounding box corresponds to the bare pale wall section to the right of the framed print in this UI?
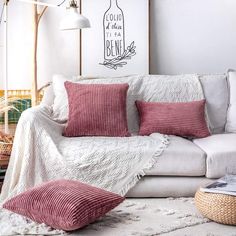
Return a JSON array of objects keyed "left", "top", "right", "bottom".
[{"left": 150, "top": 0, "right": 236, "bottom": 74}]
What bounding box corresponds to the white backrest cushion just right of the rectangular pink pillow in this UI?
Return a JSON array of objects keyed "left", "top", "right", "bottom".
[{"left": 199, "top": 75, "right": 229, "bottom": 134}]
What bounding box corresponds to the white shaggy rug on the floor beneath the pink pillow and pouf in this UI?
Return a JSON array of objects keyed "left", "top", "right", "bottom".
[{"left": 0, "top": 198, "right": 236, "bottom": 236}]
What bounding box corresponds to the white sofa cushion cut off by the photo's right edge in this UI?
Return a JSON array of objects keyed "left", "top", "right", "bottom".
[{"left": 225, "top": 70, "right": 236, "bottom": 133}]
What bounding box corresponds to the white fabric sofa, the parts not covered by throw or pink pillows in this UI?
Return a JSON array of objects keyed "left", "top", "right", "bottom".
[{"left": 42, "top": 72, "right": 236, "bottom": 197}]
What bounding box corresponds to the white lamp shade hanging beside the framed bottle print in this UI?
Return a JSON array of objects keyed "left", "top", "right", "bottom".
[{"left": 60, "top": 7, "right": 90, "bottom": 30}]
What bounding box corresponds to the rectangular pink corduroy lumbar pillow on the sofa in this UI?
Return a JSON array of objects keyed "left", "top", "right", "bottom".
[{"left": 136, "top": 100, "right": 210, "bottom": 138}]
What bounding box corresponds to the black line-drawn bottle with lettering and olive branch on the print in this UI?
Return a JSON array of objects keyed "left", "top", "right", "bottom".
[{"left": 100, "top": 0, "right": 136, "bottom": 70}]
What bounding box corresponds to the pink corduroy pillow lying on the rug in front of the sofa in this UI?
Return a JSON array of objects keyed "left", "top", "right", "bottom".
[{"left": 3, "top": 180, "right": 124, "bottom": 231}]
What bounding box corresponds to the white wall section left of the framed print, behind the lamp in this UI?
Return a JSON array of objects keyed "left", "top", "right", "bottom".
[{"left": 0, "top": 1, "right": 79, "bottom": 89}]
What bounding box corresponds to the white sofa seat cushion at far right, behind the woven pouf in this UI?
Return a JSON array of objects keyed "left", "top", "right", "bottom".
[{"left": 194, "top": 134, "right": 236, "bottom": 178}]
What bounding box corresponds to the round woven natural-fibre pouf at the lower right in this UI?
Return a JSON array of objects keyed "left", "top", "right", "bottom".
[{"left": 195, "top": 190, "right": 236, "bottom": 225}]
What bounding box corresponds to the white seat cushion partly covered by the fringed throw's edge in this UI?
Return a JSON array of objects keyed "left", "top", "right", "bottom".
[{"left": 146, "top": 136, "right": 206, "bottom": 176}]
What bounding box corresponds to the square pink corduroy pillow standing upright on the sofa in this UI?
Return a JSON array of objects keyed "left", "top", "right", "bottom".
[{"left": 63, "top": 82, "right": 130, "bottom": 137}]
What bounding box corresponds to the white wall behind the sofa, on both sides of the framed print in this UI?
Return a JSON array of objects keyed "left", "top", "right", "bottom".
[{"left": 0, "top": 0, "right": 236, "bottom": 89}]
